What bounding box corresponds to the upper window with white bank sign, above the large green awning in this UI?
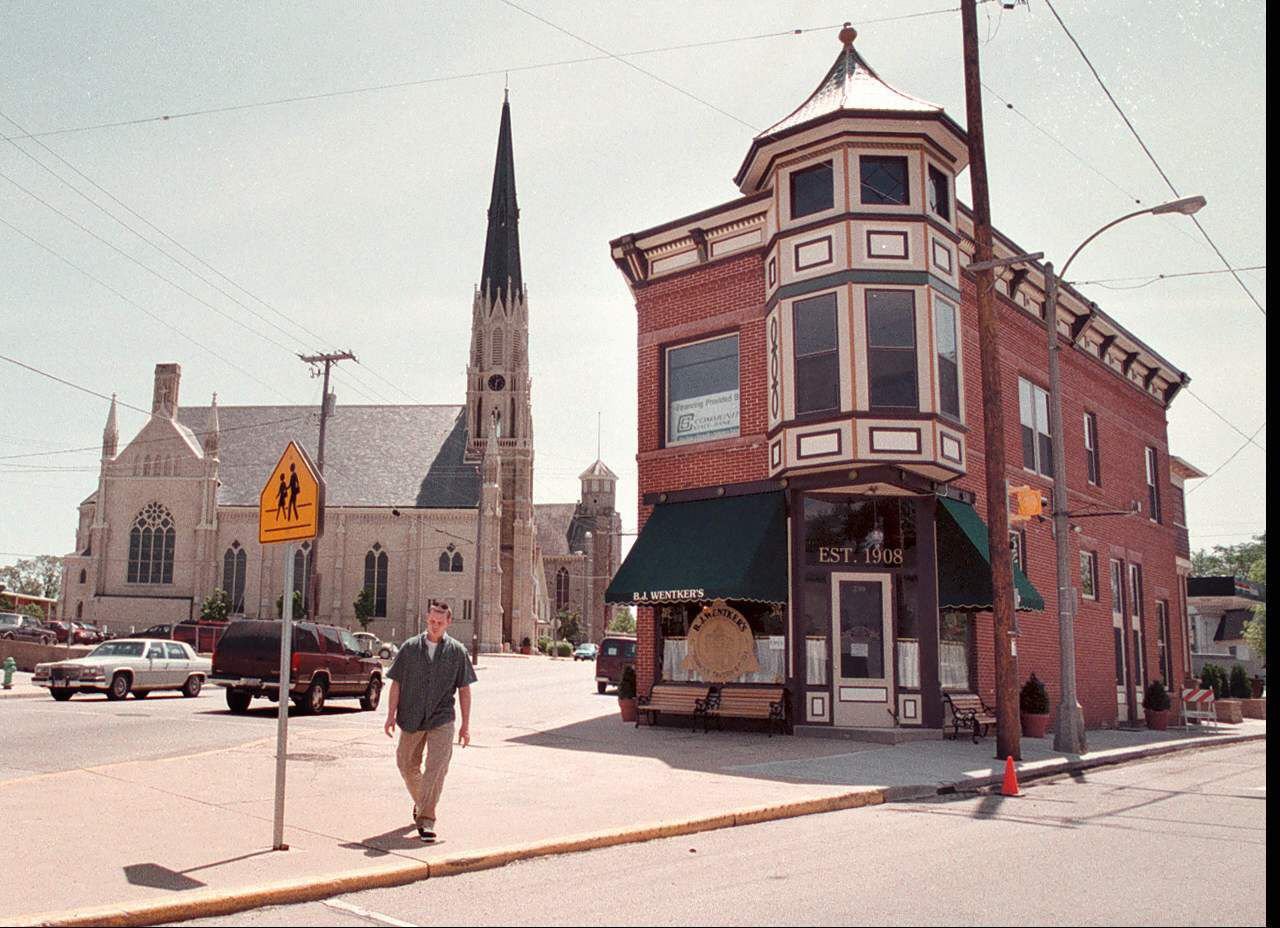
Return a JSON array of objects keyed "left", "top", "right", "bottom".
[{"left": 667, "top": 333, "right": 739, "bottom": 444}]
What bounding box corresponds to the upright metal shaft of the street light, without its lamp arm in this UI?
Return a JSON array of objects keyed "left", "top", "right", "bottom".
[{"left": 1044, "top": 261, "right": 1088, "bottom": 754}]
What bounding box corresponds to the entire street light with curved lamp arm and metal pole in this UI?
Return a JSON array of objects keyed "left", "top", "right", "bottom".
[{"left": 1002, "top": 196, "right": 1206, "bottom": 754}]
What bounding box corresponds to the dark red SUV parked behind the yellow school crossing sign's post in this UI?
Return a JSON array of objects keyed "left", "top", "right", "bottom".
[{"left": 210, "top": 620, "right": 383, "bottom": 713}]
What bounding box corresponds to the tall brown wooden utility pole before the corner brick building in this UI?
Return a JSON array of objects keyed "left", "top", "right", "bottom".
[{"left": 960, "top": 0, "right": 1021, "bottom": 760}]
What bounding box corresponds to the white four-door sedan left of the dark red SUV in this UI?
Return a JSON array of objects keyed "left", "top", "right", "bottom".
[{"left": 31, "top": 639, "right": 210, "bottom": 703}]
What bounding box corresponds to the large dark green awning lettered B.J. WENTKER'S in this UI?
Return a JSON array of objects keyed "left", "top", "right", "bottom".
[{"left": 604, "top": 493, "right": 787, "bottom": 605}]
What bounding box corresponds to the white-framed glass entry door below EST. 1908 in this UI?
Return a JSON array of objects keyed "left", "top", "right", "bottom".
[{"left": 831, "top": 573, "right": 895, "bottom": 728}]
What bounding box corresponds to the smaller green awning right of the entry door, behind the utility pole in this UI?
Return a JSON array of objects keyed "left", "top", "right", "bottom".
[{"left": 937, "top": 498, "right": 1044, "bottom": 612}]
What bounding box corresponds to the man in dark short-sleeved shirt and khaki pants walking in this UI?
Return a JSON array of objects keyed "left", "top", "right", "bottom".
[{"left": 383, "top": 599, "right": 476, "bottom": 844}]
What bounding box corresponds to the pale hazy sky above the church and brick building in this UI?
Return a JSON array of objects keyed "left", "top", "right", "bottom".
[{"left": 0, "top": 0, "right": 1267, "bottom": 563}]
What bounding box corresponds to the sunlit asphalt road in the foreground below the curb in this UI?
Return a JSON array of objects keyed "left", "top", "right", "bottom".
[{"left": 175, "top": 744, "right": 1266, "bottom": 925}]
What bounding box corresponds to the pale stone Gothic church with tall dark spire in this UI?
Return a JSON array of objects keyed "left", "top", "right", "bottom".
[{"left": 59, "top": 92, "right": 620, "bottom": 652}]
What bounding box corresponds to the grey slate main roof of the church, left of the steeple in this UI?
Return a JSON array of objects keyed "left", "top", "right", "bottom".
[{"left": 178, "top": 406, "right": 480, "bottom": 509}]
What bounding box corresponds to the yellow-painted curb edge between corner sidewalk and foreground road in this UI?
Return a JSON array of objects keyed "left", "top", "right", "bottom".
[{"left": 12, "top": 733, "right": 1266, "bottom": 928}]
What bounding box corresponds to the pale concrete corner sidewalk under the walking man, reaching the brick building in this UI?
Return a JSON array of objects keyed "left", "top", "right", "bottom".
[{"left": 0, "top": 659, "right": 1266, "bottom": 924}]
